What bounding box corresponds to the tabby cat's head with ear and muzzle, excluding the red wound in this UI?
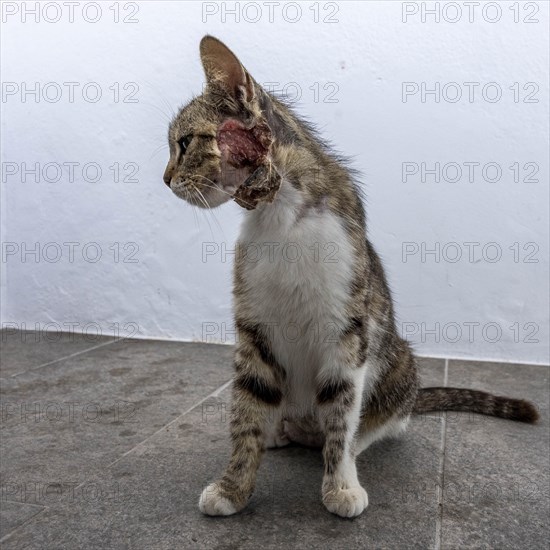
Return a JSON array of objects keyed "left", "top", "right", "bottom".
[{"left": 164, "top": 36, "right": 262, "bottom": 208}]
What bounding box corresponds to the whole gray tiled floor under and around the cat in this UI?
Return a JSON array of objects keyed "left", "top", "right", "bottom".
[{"left": 0, "top": 332, "right": 550, "bottom": 550}]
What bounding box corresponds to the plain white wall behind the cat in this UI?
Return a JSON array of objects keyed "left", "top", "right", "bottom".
[{"left": 1, "top": 1, "right": 549, "bottom": 362}]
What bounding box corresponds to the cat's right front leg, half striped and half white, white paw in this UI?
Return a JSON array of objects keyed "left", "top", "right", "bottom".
[{"left": 317, "top": 367, "right": 368, "bottom": 518}]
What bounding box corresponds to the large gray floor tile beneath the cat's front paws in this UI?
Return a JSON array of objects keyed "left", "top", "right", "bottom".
[{"left": 4, "top": 391, "right": 441, "bottom": 549}]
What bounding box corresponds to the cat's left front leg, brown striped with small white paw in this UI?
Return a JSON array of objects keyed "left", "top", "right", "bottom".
[{"left": 199, "top": 324, "right": 284, "bottom": 516}]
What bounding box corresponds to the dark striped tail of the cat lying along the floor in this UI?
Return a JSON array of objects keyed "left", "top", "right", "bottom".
[{"left": 413, "top": 388, "right": 539, "bottom": 424}]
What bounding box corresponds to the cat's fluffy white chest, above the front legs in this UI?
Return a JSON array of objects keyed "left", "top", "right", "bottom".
[{"left": 236, "top": 193, "right": 354, "bottom": 364}]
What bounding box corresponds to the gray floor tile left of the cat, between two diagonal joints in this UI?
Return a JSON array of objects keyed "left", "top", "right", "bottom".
[{"left": 0, "top": 340, "right": 232, "bottom": 496}]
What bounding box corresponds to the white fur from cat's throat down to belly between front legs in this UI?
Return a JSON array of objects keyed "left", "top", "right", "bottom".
[{"left": 239, "top": 181, "right": 354, "bottom": 418}]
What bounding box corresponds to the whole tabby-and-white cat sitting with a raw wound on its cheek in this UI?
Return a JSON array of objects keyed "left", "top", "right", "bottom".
[{"left": 164, "top": 36, "right": 538, "bottom": 517}]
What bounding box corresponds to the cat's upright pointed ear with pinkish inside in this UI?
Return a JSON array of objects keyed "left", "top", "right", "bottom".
[{"left": 200, "top": 35, "right": 254, "bottom": 102}]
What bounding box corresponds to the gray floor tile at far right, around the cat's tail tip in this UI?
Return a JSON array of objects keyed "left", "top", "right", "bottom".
[{"left": 441, "top": 361, "right": 550, "bottom": 549}]
